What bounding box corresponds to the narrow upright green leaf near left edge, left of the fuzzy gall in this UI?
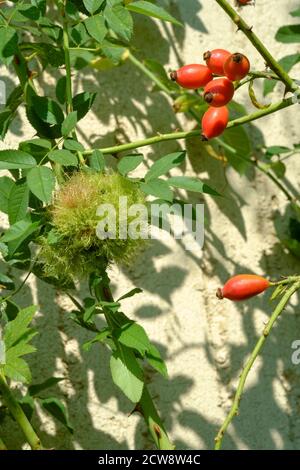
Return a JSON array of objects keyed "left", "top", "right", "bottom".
[{"left": 7, "top": 179, "right": 29, "bottom": 224}]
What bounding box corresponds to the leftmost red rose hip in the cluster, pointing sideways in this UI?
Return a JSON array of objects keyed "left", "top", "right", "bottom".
[{"left": 170, "top": 64, "right": 213, "bottom": 90}]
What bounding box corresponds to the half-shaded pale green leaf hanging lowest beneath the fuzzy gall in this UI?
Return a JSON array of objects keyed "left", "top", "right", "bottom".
[{"left": 110, "top": 346, "right": 144, "bottom": 403}]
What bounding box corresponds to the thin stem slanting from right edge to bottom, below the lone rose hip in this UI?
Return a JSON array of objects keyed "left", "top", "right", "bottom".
[{"left": 215, "top": 277, "right": 300, "bottom": 450}]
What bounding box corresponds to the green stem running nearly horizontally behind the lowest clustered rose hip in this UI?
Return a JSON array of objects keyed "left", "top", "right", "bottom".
[{"left": 82, "top": 98, "right": 294, "bottom": 155}]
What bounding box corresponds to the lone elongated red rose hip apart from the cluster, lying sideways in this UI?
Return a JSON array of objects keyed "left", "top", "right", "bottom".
[{"left": 216, "top": 274, "right": 270, "bottom": 301}]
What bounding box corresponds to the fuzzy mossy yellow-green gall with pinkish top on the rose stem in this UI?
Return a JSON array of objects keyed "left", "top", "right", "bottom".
[{"left": 41, "top": 172, "right": 146, "bottom": 278}]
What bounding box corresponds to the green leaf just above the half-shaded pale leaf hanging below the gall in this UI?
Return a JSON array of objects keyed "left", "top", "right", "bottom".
[{"left": 113, "top": 322, "right": 150, "bottom": 356}]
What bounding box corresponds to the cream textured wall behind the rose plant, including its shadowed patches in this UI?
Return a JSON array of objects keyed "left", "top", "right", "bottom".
[{"left": 2, "top": 0, "right": 300, "bottom": 449}]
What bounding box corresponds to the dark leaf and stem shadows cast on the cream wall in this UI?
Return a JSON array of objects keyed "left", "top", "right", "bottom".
[{"left": 4, "top": 0, "right": 300, "bottom": 449}]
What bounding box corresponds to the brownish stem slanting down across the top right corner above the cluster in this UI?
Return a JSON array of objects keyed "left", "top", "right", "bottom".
[{"left": 216, "top": 0, "right": 297, "bottom": 91}]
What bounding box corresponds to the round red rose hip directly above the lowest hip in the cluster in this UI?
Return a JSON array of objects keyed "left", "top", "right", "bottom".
[{"left": 203, "top": 78, "right": 234, "bottom": 108}]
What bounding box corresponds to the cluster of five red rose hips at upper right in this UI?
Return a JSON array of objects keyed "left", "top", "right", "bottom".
[{"left": 170, "top": 49, "right": 250, "bottom": 140}]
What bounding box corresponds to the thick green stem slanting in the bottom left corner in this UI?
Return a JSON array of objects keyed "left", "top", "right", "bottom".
[{"left": 0, "top": 372, "right": 42, "bottom": 450}]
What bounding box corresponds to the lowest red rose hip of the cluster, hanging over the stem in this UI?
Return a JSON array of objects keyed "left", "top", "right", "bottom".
[{"left": 202, "top": 106, "right": 229, "bottom": 140}]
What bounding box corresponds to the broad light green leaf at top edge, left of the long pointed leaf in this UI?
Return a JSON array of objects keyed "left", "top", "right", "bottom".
[{"left": 104, "top": 4, "right": 133, "bottom": 41}]
